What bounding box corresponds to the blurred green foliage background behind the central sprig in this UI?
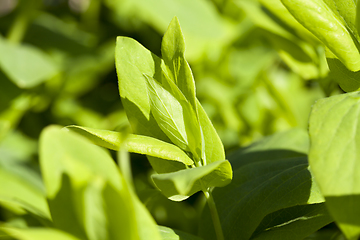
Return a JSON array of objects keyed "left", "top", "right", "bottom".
[{"left": 0, "top": 0, "right": 340, "bottom": 232}]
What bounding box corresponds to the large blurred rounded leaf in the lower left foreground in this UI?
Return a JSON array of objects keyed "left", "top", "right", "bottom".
[{"left": 40, "top": 126, "right": 139, "bottom": 239}]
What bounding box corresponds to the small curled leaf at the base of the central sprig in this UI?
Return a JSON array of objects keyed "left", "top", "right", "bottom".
[{"left": 152, "top": 160, "right": 232, "bottom": 201}]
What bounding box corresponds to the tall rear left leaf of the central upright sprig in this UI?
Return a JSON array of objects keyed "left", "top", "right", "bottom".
[{"left": 115, "top": 37, "right": 170, "bottom": 141}]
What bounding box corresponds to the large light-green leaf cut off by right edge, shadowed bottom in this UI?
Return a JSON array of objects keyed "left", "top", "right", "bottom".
[{"left": 309, "top": 92, "right": 360, "bottom": 239}]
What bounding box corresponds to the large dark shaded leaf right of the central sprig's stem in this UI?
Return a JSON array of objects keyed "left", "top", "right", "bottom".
[{"left": 199, "top": 129, "right": 332, "bottom": 240}]
